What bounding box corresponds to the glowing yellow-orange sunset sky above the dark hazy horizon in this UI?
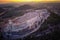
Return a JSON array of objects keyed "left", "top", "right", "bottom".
[{"left": 0, "top": 0, "right": 60, "bottom": 3}]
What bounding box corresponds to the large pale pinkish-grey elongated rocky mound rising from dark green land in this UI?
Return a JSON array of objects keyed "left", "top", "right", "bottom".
[{"left": 3, "top": 9, "right": 50, "bottom": 39}]
